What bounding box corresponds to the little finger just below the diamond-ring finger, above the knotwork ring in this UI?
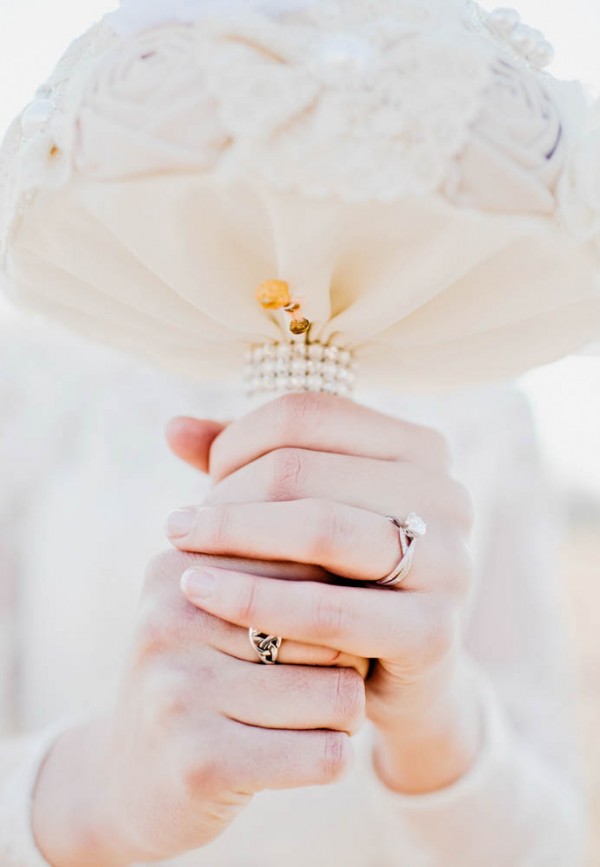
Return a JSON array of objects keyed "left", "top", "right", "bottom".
[{"left": 182, "top": 568, "right": 426, "bottom": 659}]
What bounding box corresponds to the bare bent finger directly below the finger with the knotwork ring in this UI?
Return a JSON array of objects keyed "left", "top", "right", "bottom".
[{"left": 217, "top": 660, "right": 365, "bottom": 734}]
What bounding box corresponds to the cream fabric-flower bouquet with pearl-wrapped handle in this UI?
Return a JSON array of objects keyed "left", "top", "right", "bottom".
[{"left": 0, "top": 0, "right": 600, "bottom": 394}]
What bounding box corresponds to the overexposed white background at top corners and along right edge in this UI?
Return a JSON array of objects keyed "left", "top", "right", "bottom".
[{"left": 0, "top": 0, "right": 600, "bottom": 867}]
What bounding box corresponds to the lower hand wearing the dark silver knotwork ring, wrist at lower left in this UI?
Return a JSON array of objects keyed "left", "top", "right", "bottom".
[{"left": 33, "top": 551, "right": 366, "bottom": 867}]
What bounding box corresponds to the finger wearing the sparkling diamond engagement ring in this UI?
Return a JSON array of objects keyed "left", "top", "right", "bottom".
[{"left": 167, "top": 499, "right": 429, "bottom": 586}]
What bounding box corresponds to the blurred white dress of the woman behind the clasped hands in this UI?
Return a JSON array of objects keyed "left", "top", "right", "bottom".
[{"left": 0, "top": 325, "right": 583, "bottom": 867}]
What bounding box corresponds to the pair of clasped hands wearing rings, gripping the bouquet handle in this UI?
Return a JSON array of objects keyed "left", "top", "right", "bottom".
[{"left": 34, "top": 394, "right": 478, "bottom": 867}]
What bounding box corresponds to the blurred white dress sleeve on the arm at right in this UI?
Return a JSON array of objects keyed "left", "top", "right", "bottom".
[{"left": 360, "top": 392, "right": 586, "bottom": 867}]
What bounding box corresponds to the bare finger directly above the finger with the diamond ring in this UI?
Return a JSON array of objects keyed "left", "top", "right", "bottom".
[{"left": 204, "top": 448, "right": 472, "bottom": 529}]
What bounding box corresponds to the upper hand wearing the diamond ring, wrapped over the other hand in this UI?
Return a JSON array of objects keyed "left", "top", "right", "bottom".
[{"left": 168, "top": 394, "right": 478, "bottom": 791}]
